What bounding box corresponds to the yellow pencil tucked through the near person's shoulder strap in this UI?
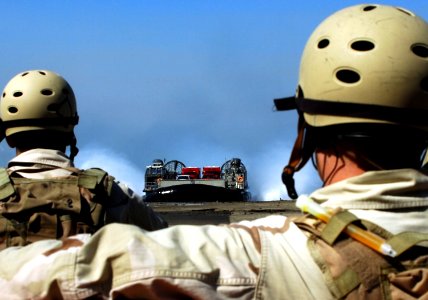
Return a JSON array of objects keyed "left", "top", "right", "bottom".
[{"left": 296, "top": 195, "right": 397, "bottom": 257}]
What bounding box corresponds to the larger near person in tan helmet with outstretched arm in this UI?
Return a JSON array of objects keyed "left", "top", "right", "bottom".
[{"left": 0, "top": 5, "right": 428, "bottom": 299}]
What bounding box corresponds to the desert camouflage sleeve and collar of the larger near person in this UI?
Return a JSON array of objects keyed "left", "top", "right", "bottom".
[{"left": 0, "top": 169, "right": 428, "bottom": 299}]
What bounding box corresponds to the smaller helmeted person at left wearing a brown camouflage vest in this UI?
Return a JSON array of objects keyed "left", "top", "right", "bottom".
[{"left": 0, "top": 70, "right": 166, "bottom": 248}]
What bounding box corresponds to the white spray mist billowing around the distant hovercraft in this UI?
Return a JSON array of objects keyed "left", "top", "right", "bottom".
[{"left": 75, "top": 144, "right": 321, "bottom": 201}]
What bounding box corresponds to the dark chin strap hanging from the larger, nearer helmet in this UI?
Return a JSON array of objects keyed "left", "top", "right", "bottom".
[{"left": 281, "top": 115, "right": 313, "bottom": 199}]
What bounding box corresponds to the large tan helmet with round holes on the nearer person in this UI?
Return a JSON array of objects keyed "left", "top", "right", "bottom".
[{"left": 275, "top": 5, "right": 428, "bottom": 197}]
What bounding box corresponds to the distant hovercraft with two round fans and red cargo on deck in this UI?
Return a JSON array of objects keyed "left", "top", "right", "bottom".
[{"left": 144, "top": 158, "right": 251, "bottom": 202}]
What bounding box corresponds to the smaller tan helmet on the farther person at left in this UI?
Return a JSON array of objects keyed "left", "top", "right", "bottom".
[{"left": 0, "top": 70, "right": 79, "bottom": 158}]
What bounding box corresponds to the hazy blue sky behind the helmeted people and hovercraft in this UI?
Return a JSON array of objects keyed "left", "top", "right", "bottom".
[{"left": 0, "top": 0, "right": 428, "bottom": 200}]
